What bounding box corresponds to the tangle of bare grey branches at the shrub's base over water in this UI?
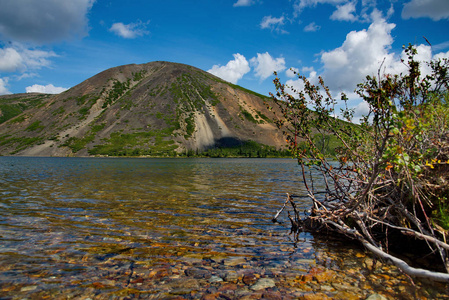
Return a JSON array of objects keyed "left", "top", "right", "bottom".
[{"left": 274, "top": 134, "right": 449, "bottom": 283}]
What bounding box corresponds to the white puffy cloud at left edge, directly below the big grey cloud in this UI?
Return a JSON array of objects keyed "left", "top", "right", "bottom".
[{"left": 0, "top": 43, "right": 56, "bottom": 72}]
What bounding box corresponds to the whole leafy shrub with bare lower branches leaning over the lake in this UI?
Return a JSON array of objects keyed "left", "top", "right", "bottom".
[{"left": 272, "top": 45, "right": 449, "bottom": 281}]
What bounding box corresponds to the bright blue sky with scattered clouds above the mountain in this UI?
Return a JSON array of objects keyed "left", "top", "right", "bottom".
[{"left": 0, "top": 0, "right": 449, "bottom": 119}]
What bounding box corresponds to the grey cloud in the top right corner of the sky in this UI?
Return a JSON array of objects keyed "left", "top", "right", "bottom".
[{"left": 402, "top": 0, "right": 449, "bottom": 21}]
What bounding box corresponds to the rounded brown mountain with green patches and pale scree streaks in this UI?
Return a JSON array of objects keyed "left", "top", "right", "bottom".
[{"left": 0, "top": 62, "right": 285, "bottom": 156}]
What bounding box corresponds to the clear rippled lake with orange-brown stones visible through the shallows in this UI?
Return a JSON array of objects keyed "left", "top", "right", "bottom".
[{"left": 0, "top": 157, "right": 447, "bottom": 299}]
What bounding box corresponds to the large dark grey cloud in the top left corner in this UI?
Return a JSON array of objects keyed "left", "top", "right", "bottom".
[{"left": 0, "top": 0, "right": 95, "bottom": 44}]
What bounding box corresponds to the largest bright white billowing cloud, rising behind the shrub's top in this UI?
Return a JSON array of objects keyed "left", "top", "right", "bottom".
[{"left": 304, "top": 14, "right": 449, "bottom": 110}]
